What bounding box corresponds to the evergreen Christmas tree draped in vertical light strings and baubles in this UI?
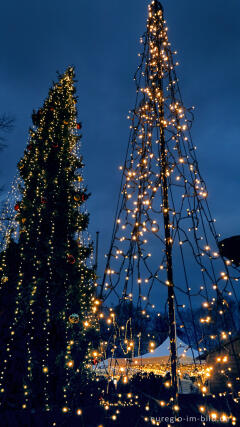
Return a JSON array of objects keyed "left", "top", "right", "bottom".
[{"left": 0, "top": 67, "right": 96, "bottom": 412}]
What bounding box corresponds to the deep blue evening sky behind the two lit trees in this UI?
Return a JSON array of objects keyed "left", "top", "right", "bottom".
[{"left": 0, "top": 0, "right": 240, "bottom": 278}]
